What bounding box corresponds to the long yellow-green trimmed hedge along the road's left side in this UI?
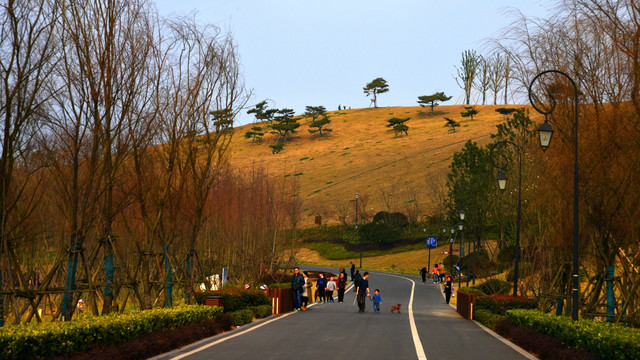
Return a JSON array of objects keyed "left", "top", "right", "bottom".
[{"left": 0, "top": 306, "right": 222, "bottom": 359}]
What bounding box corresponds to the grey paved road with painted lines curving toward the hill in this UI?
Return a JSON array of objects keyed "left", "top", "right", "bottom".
[{"left": 154, "top": 267, "right": 533, "bottom": 360}]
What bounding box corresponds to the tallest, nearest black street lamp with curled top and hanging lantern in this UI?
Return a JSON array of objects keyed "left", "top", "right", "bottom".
[{"left": 528, "top": 70, "right": 580, "bottom": 320}]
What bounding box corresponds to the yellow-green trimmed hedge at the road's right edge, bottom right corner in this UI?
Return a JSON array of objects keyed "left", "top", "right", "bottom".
[{"left": 506, "top": 310, "right": 640, "bottom": 360}]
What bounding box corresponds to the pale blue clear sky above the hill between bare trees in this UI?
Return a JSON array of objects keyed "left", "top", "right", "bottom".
[{"left": 155, "top": 0, "right": 550, "bottom": 124}]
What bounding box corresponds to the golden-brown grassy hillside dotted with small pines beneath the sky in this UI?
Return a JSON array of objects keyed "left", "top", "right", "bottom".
[{"left": 230, "top": 105, "right": 536, "bottom": 226}]
